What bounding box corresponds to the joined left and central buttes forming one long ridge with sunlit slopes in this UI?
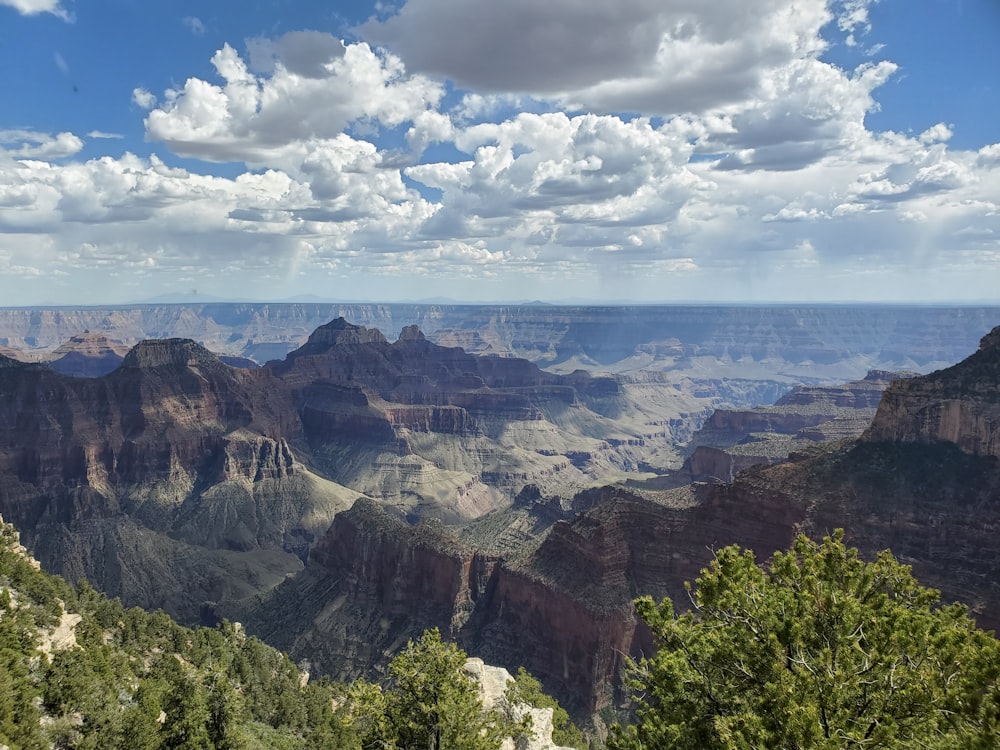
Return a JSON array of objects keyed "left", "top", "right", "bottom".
[{"left": 0, "top": 319, "right": 704, "bottom": 622}]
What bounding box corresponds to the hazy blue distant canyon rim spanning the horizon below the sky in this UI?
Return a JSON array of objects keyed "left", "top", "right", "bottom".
[{"left": 0, "top": 303, "right": 1000, "bottom": 388}]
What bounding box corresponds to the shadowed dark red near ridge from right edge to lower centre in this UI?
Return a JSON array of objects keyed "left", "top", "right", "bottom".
[{"left": 225, "top": 329, "right": 1000, "bottom": 716}]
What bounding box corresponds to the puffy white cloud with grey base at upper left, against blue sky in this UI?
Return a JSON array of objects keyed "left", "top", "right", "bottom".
[{"left": 146, "top": 38, "right": 444, "bottom": 165}]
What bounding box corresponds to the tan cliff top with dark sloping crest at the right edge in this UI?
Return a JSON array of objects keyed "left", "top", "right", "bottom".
[{"left": 865, "top": 328, "right": 1000, "bottom": 456}]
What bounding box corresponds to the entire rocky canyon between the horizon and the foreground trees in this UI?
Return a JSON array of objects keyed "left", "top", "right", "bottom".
[{"left": 0, "top": 305, "right": 1000, "bottom": 717}]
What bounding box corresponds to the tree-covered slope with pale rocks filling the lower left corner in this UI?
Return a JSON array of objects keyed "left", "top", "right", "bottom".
[{"left": 0, "top": 524, "right": 580, "bottom": 750}]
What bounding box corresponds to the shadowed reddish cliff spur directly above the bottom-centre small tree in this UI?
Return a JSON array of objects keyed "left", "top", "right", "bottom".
[{"left": 233, "top": 500, "right": 499, "bottom": 679}]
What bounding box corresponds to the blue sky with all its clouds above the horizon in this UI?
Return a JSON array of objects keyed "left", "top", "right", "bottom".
[{"left": 0, "top": 0, "right": 1000, "bottom": 306}]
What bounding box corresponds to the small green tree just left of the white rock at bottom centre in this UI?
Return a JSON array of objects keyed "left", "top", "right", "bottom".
[{"left": 386, "top": 628, "right": 506, "bottom": 750}]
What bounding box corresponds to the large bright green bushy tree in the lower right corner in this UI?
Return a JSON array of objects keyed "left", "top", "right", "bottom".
[{"left": 609, "top": 531, "right": 1000, "bottom": 750}]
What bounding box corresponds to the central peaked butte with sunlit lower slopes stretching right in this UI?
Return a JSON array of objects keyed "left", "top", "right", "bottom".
[{"left": 266, "top": 319, "right": 703, "bottom": 521}]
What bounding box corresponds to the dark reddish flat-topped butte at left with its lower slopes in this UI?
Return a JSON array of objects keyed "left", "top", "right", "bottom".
[{"left": 0, "top": 339, "right": 356, "bottom": 621}]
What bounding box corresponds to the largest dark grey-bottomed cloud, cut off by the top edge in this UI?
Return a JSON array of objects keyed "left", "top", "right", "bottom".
[{"left": 359, "top": 0, "right": 869, "bottom": 115}]
